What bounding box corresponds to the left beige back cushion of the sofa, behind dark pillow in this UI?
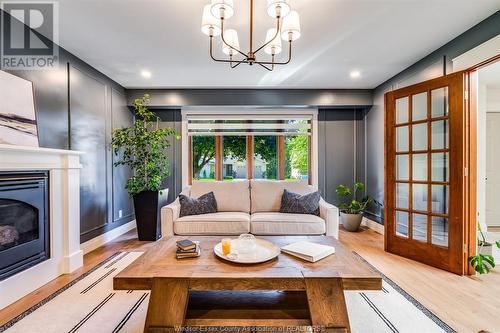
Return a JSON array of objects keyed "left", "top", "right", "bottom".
[{"left": 191, "top": 180, "right": 250, "bottom": 213}]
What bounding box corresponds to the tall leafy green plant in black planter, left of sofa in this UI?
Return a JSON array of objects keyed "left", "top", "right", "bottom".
[{"left": 111, "top": 94, "right": 180, "bottom": 241}]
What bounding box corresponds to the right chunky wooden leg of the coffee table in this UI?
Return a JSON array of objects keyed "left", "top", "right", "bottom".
[{"left": 305, "top": 278, "right": 351, "bottom": 332}]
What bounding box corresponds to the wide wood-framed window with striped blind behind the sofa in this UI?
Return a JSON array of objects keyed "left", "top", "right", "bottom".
[{"left": 186, "top": 110, "right": 313, "bottom": 183}]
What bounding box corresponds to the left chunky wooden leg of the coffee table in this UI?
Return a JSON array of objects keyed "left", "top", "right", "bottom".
[{"left": 144, "top": 278, "right": 189, "bottom": 333}]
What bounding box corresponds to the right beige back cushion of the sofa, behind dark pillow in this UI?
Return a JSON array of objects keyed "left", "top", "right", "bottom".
[{"left": 250, "top": 180, "right": 316, "bottom": 213}]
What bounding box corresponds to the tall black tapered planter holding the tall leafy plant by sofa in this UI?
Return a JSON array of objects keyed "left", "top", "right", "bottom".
[{"left": 134, "top": 189, "right": 168, "bottom": 241}]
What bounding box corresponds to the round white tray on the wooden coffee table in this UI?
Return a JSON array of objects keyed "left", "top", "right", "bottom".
[{"left": 214, "top": 238, "right": 281, "bottom": 264}]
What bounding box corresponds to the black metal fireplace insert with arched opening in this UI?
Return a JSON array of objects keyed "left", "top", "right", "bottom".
[{"left": 0, "top": 171, "right": 50, "bottom": 280}]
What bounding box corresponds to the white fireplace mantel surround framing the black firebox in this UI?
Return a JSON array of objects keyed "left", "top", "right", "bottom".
[{"left": 0, "top": 144, "right": 83, "bottom": 309}]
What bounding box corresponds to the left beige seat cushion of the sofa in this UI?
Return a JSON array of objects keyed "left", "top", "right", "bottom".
[{"left": 174, "top": 212, "right": 250, "bottom": 235}]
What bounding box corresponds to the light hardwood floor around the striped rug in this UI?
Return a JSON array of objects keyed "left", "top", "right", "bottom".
[{"left": 0, "top": 230, "right": 500, "bottom": 332}]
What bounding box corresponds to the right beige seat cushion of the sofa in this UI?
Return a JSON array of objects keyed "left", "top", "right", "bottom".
[{"left": 250, "top": 212, "right": 326, "bottom": 235}]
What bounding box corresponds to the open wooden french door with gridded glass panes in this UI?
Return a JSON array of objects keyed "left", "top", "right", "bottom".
[{"left": 385, "top": 72, "right": 467, "bottom": 274}]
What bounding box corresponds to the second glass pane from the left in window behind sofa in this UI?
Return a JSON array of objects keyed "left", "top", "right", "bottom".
[{"left": 222, "top": 136, "right": 247, "bottom": 181}]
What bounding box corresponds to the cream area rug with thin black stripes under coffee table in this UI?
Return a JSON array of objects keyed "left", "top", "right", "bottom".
[{"left": 0, "top": 252, "right": 454, "bottom": 333}]
